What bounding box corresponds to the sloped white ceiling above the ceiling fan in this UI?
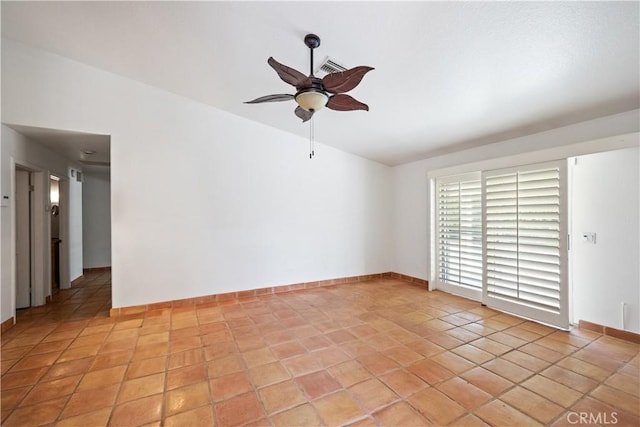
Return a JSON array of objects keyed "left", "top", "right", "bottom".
[{"left": 2, "top": 1, "right": 640, "bottom": 165}]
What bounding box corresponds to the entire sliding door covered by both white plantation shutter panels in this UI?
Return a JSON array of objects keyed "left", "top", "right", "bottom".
[{"left": 435, "top": 161, "right": 569, "bottom": 328}]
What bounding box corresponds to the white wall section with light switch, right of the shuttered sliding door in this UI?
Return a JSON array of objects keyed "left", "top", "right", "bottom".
[{"left": 570, "top": 147, "right": 640, "bottom": 333}]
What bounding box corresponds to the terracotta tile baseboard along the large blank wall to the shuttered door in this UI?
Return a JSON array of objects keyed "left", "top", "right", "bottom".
[{"left": 109, "top": 272, "right": 429, "bottom": 317}]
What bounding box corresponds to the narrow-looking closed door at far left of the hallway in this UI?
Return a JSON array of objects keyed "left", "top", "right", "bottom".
[{"left": 15, "top": 169, "right": 31, "bottom": 309}]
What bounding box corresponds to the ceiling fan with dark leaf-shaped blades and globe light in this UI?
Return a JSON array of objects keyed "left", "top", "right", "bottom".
[{"left": 245, "top": 34, "right": 373, "bottom": 122}]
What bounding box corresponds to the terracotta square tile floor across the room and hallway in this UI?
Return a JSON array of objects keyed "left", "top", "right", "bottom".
[{"left": 1, "top": 273, "right": 640, "bottom": 427}]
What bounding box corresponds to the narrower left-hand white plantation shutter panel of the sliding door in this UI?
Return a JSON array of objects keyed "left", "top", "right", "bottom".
[{"left": 437, "top": 173, "right": 482, "bottom": 298}]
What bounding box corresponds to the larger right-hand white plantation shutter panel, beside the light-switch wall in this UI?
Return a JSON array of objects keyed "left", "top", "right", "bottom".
[{"left": 483, "top": 162, "right": 568, "bottom": 328}]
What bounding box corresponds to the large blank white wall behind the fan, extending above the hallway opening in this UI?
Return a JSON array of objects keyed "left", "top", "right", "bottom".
[{"left": 2, "top": 39, "right": 393, "bottom": 307}]
